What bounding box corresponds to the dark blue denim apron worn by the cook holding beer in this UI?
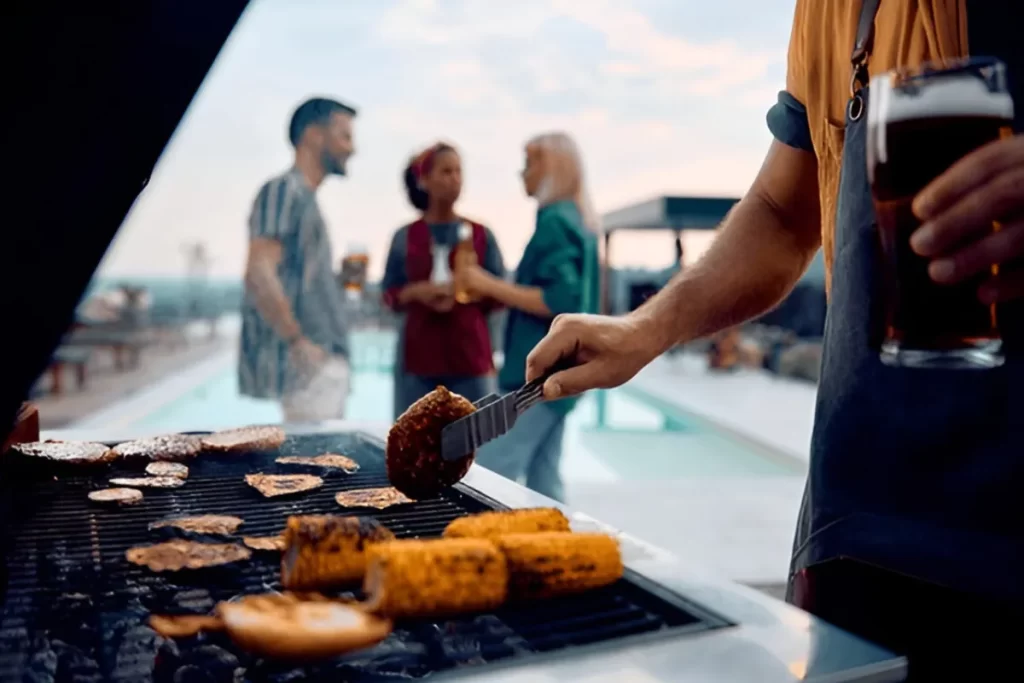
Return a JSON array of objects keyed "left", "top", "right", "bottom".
[{"left": 790, "top": 0, "right": 1024, "bottom": 599}]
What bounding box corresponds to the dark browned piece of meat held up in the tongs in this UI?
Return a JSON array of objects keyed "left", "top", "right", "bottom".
[{"left": 385, "top": 386, "right": 476, "bottom": 500}]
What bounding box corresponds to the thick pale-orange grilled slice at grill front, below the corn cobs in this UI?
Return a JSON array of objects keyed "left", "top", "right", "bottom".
[{"left": 217, "top": 593, "right": 391, "bottom": 661}]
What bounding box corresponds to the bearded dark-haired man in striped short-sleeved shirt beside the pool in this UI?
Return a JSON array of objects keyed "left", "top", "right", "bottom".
[{"left": 239, "top": 97, "right": 355, "bottom": 422}]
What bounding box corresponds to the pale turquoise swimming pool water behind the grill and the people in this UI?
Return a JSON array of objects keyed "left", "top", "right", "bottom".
[{"left": 125, "top": 332, "right": 804, "bottom": 482}]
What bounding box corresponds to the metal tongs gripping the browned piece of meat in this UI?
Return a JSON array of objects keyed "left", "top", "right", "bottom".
[{"left": 441, "top": 358, "right": 575, "bottom": 460}]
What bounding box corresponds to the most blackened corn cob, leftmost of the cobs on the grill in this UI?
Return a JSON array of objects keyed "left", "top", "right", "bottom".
[{"left": 281, "top": 515, "right": 394, "bottom": 589}]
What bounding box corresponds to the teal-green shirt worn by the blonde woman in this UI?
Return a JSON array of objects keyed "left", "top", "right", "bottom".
[{"left": 498, "top": 196, "right": 600, "bottom": 413}]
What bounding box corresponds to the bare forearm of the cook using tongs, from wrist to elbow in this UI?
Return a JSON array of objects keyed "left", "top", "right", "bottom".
[{"left": 632, "top": 189, "right": 820, "bottom": 353}]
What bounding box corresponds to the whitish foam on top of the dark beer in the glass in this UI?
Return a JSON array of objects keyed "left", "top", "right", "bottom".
[{"left": 871, "top": 74, "right": 1014, "bottom": 123}]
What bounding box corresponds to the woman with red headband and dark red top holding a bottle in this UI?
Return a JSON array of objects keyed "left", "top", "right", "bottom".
[{"left": 382, "top": 142, "right": 505, "bottom": 419}]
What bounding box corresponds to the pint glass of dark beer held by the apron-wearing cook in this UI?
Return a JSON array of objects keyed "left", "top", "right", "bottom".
[{"left": 867, "top": 57, "right": 1014, "bottom": 369}]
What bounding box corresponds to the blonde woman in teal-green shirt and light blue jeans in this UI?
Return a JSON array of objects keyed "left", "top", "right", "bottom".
[{"left": 466, "top": 133, "right": 600, "bottom": 501}]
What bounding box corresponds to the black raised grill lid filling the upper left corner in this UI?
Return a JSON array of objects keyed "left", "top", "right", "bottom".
[{"left": 0, "top": 0, "right": 249, "bottom": 443}]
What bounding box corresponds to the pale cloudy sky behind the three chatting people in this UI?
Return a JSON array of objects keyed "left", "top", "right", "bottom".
[{"left": 100, "top": 0, "right": 794, "bottom": 276}]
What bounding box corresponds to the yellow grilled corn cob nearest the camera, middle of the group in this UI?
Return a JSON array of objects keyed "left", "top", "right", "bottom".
[{"left": 362, "top": 539, "right": 509, "bottom": 618}]
